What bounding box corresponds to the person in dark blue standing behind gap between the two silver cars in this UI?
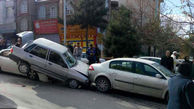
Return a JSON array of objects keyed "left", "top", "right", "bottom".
[{"left": 86, "top": 44, "right": 96, "bottom": 65}]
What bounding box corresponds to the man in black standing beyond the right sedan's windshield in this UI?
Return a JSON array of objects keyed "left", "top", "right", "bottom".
[{"left": 161, "top": 50, "right": 174, "bottom": 72}]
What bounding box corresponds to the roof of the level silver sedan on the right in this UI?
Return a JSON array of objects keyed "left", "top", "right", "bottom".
[{"left": 110, "top": 58, "right": 156, "bottom": 65}]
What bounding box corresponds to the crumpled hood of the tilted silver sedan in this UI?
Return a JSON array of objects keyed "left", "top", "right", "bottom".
[{"left": 71, "top": 61, "right": 89, "bottom": 76}]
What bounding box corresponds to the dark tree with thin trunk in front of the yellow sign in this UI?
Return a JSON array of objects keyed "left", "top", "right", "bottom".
[{"left": 68, "top": 0, "right": 108, "bottom": 48}]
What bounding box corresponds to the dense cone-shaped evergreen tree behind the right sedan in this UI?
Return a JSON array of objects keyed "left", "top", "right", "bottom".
[{"left": 104, "top": 6, "right": 140, "bottom": 58}]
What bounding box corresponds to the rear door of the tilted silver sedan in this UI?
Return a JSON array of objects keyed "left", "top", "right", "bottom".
[{"left": 25, "top": 45, "right": 48, "bottom": 72}]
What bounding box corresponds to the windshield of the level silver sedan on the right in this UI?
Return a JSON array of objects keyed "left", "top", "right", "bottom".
[{"left": 152, "top": 63, "right": 173, "bottom": 77}]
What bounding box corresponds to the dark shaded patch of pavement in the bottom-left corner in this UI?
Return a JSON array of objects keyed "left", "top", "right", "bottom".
[{"left": 0, "top": 95, "right": 17, "bottom": 109}]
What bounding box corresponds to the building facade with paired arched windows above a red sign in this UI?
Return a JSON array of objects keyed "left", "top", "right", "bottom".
[{"left": 33, "top": 0, "right": 60, "bottom": 43}]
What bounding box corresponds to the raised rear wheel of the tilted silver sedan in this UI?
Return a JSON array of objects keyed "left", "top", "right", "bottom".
[{"left": 18, "top": 61, "right": 30, "bottom": 74}]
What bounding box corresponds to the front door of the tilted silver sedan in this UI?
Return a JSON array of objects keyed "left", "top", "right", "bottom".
[{"left": 46, "top": 51, "right": 69, "bottom": 80}]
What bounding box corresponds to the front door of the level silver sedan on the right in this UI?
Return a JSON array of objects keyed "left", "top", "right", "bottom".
[{"left": 134, "top": 62, "right": 166, "bottom": 97}]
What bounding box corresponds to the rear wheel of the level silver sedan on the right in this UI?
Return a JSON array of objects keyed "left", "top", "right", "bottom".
[{"left": 96, "top": 79, "right": 109, "bottom": 92}]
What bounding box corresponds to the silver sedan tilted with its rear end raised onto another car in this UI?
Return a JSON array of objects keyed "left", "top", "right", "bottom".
[{"left": 10, "top": 38, "right": 88, "bottom": 88}]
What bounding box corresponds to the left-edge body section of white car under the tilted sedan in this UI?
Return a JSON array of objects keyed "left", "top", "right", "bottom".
[{"left": 0, "top": 50, "right": 21, "bottom": 74}]
